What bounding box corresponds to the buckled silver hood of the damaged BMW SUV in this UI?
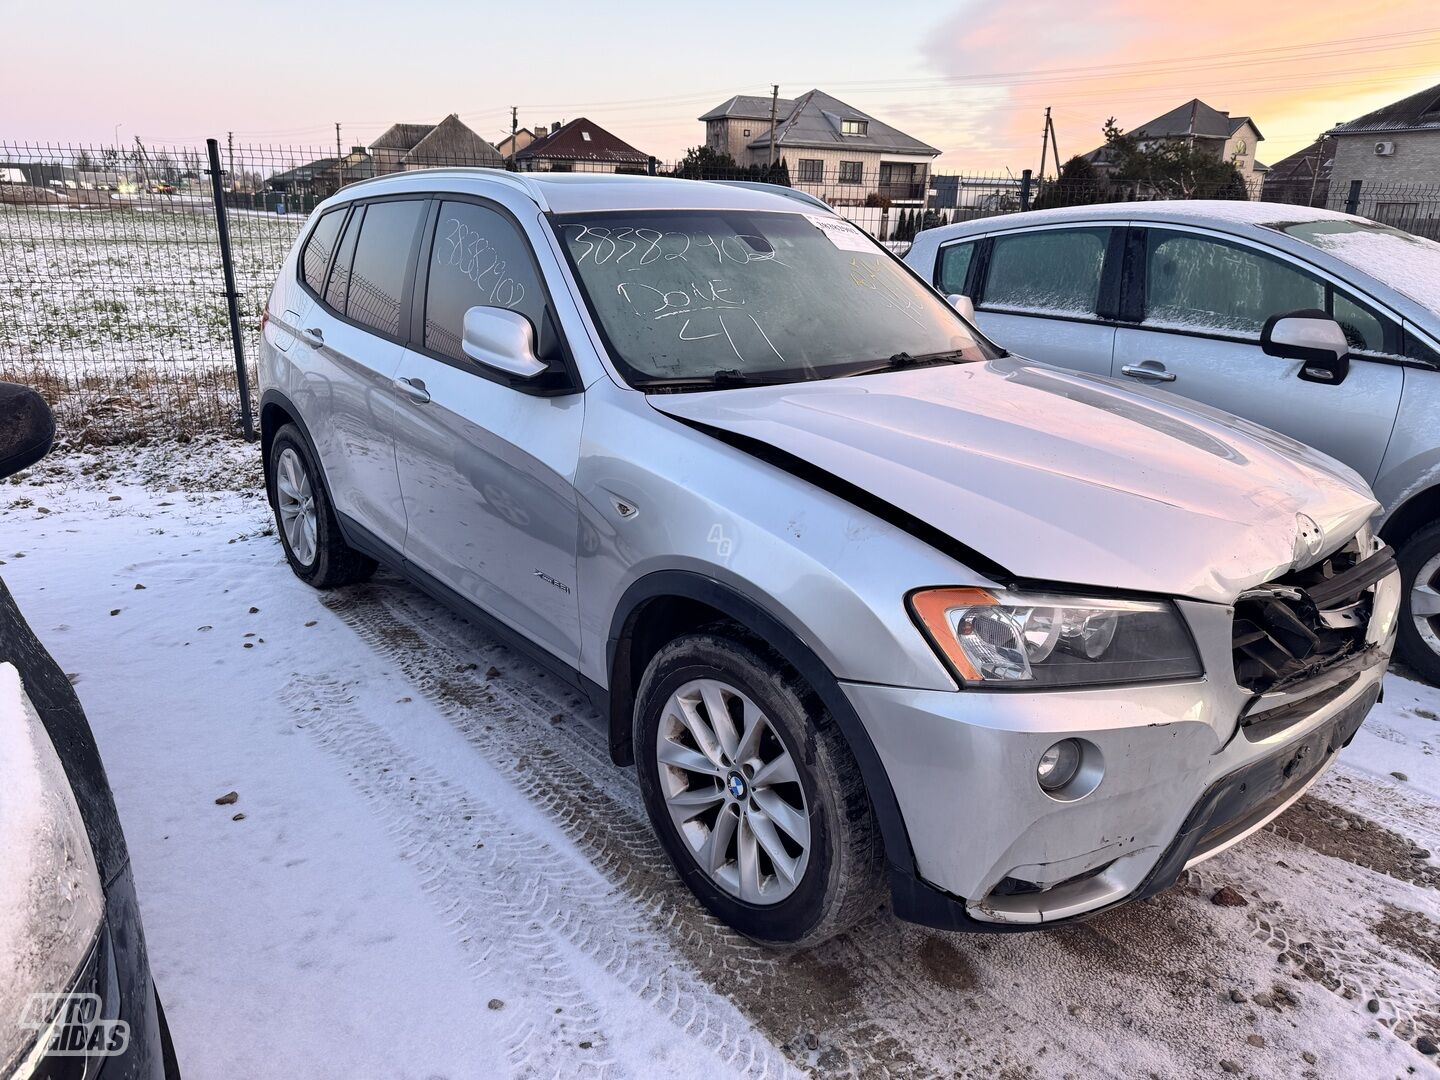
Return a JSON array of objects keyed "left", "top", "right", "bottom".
[{"left": 649, "top": 357, "right": 1380, "bottom": 603}]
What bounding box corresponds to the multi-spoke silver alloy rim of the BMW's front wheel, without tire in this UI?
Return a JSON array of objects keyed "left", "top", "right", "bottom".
[{"left": 655, "top": 678, "right": 811, "bottom": 904}]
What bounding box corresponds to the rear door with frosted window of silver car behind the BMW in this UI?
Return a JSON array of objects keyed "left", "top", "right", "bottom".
[{"left": 936, "top": 223, "right": 1123, "bottom": 374}]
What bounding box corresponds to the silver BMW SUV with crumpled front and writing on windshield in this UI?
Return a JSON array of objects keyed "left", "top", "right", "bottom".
[{"left": 261, "top": 170, "right": 1400, "bottom": 943}]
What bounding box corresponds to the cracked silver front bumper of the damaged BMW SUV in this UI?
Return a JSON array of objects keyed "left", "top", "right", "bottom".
[{"left": 844, "top": 558, "right": 1400, "bottom": 930}]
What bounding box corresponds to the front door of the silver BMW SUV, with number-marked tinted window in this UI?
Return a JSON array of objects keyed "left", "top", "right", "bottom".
[{"left": 396, "top": 196, "right": 585, "bottom": 664}]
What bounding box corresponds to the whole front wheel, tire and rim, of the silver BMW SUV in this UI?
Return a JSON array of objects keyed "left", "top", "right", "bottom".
[{"left": 635, "top": 631, "right": 884, "bottom": 946}]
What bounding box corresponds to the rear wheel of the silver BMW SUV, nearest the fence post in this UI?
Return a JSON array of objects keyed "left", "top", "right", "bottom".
[{"left": 268, "top": 423, "right": 376, "bottom": 589}]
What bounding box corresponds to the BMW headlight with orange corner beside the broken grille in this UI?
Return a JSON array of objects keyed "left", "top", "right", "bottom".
[{"left": 910, "top": 589, "right": 1201, "bottom": 688}]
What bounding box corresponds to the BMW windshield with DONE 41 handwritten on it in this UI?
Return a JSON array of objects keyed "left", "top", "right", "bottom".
[{"left": 556, "top": 210, "right": 991, "bottom": 389}]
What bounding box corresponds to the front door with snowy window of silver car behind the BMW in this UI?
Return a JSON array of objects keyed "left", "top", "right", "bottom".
[{"left": 1113, "top": 226, "right": 1403, "bottom": 480}]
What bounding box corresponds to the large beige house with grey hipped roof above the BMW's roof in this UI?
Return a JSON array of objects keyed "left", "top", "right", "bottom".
[{"left": 700, "top": 89, "right": 940, "bottom": 206}]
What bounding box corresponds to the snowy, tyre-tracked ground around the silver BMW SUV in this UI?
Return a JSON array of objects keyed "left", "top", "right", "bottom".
[{"left": 0, "top": 441, "right": 1440, "bottom": 1080}]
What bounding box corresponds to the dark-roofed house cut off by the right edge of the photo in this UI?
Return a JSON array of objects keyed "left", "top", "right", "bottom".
[{"left": 1325, "top": 86, "right": 1440, "bottom": 193}]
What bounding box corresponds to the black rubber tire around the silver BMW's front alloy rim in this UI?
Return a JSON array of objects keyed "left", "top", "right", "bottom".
[{"left": 634, "top": 626, "right": 884, "bottom": 948}]
